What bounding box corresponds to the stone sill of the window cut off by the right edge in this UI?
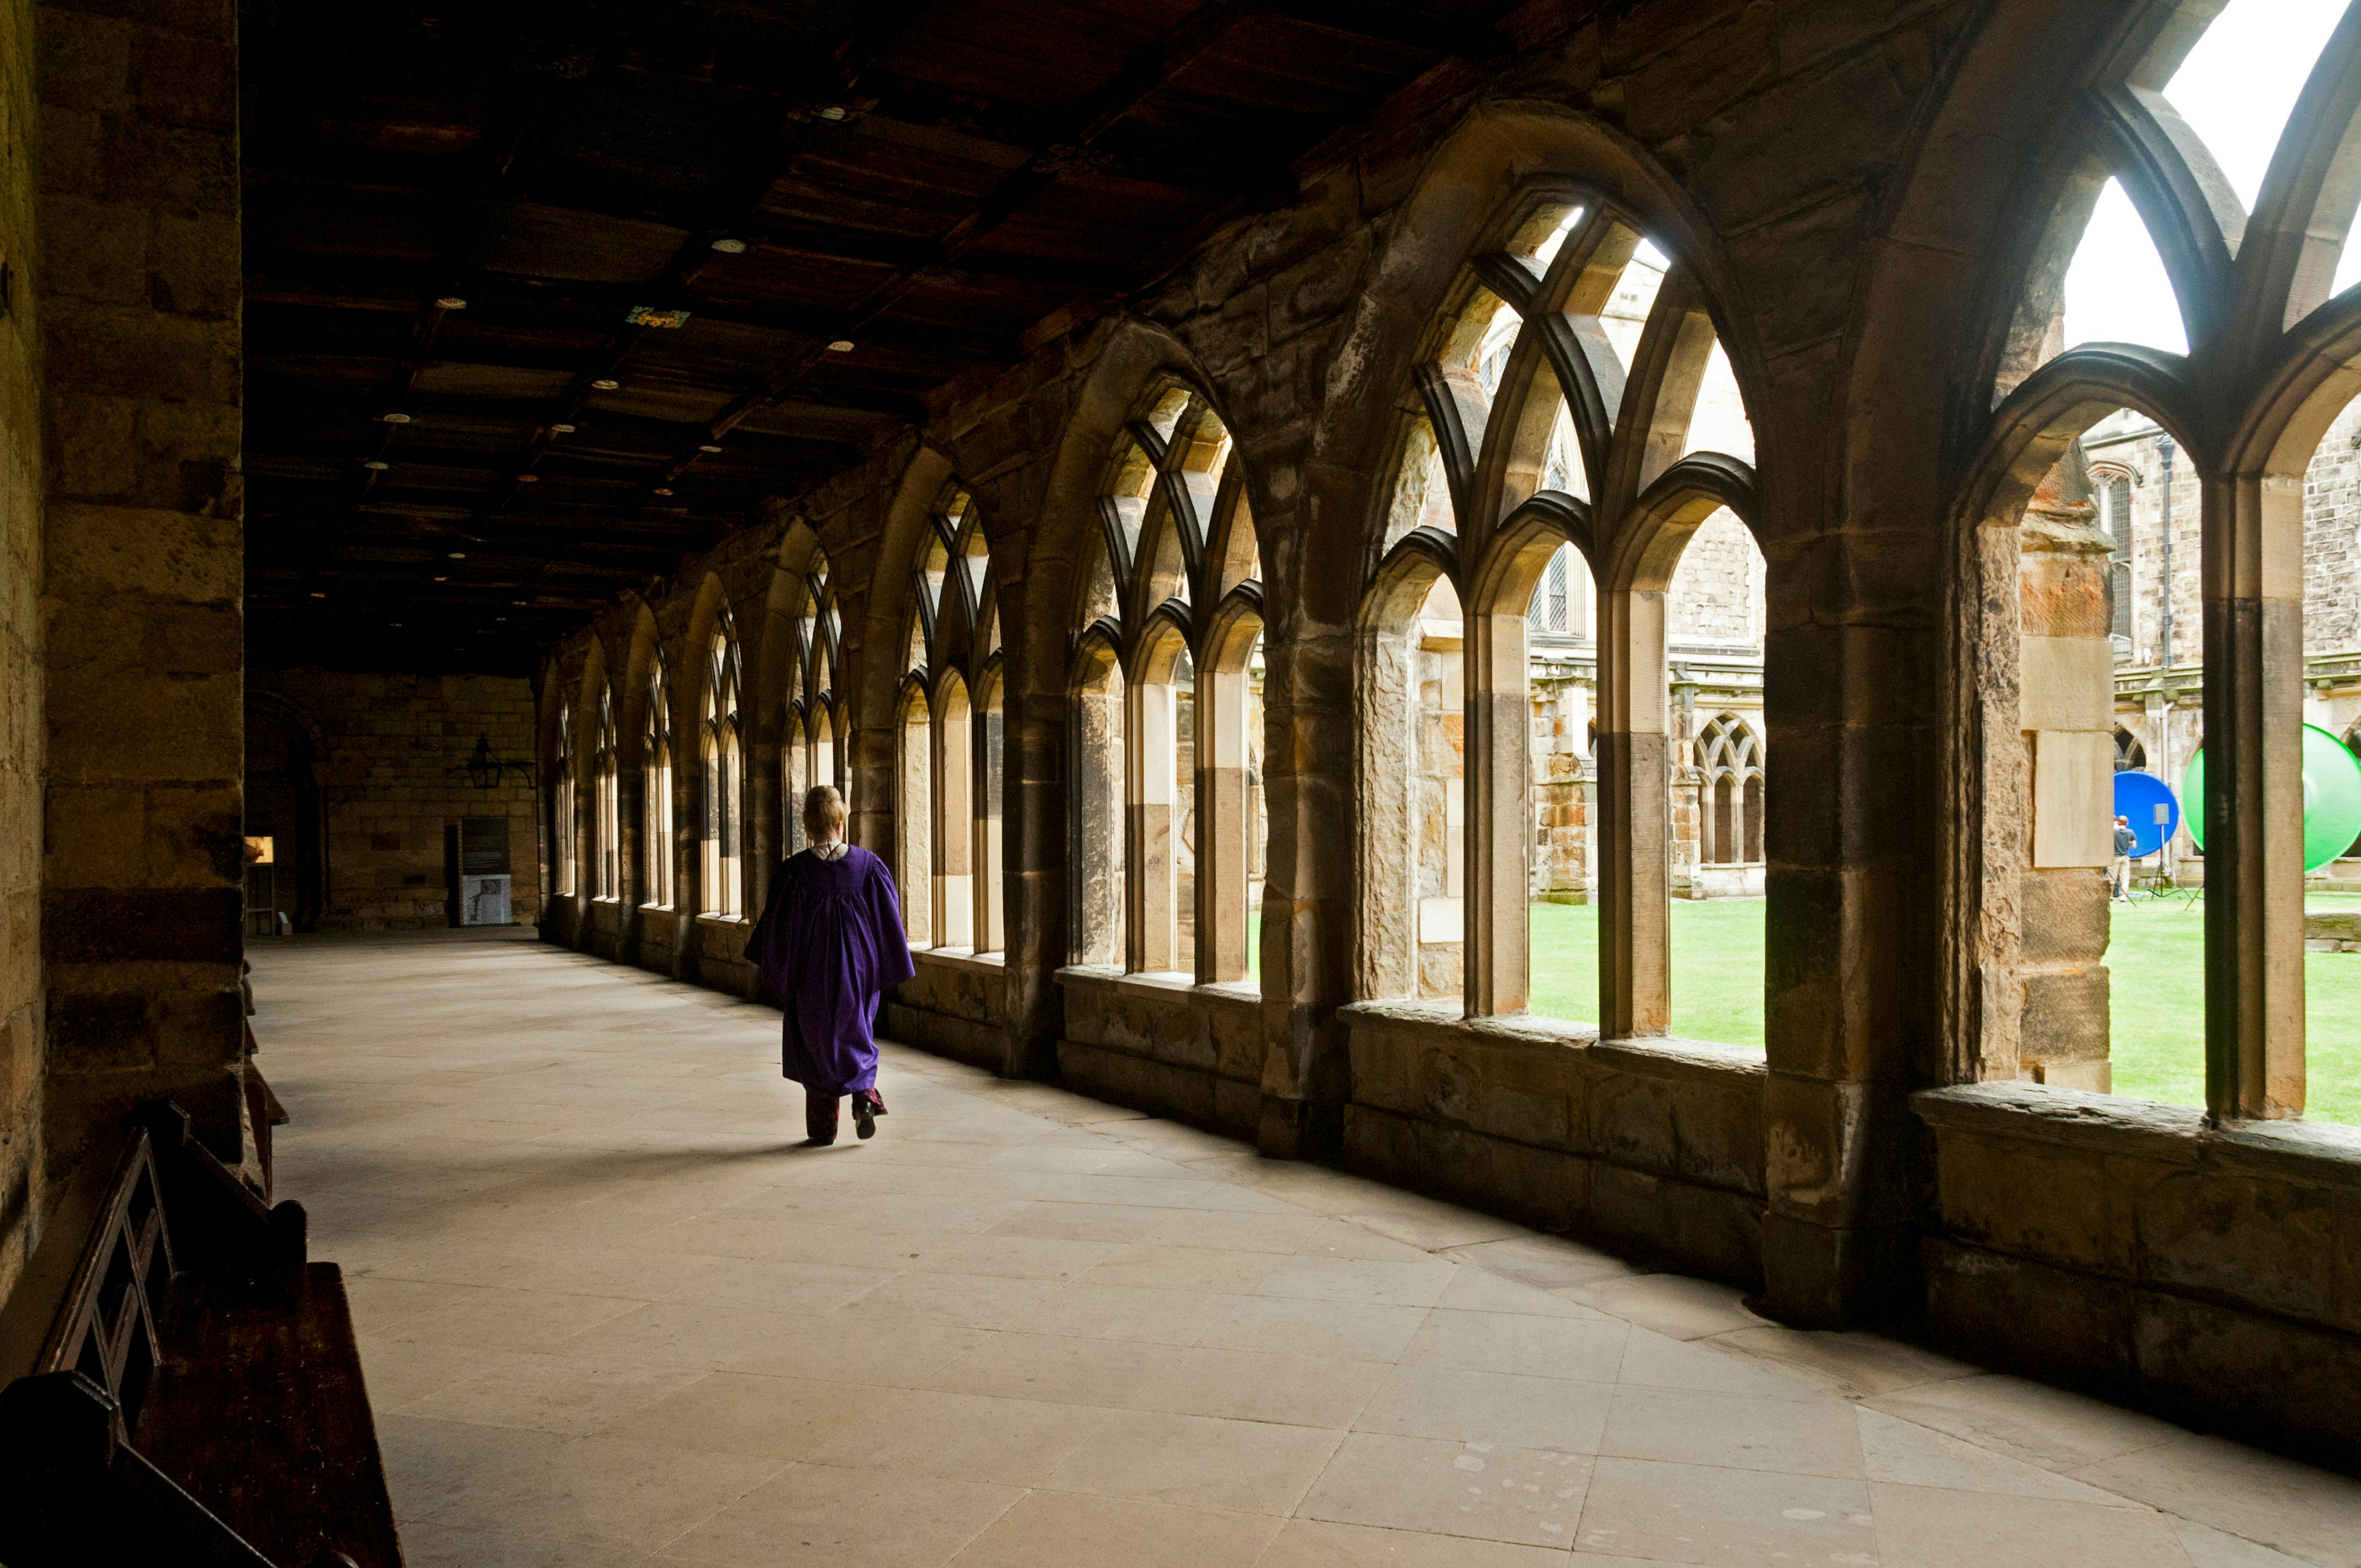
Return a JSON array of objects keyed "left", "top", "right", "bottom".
[{"left": 1910, "top": 1082, "right": 2361, "bottom": 1188}]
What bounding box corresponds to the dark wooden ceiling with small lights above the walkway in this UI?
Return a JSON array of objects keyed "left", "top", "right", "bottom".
[{"left": 243, "top": 0, "right": 1511, "bottom": 673}]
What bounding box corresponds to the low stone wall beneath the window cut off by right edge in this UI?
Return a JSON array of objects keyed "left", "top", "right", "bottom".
[{"left": 1912, "top": 1084, "right": 2361, "bottom": 1464}]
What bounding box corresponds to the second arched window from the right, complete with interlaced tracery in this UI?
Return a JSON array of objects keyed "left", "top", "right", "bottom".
[{"left": 1355, "top": 189, "right": 1768, "bottom": 1043}]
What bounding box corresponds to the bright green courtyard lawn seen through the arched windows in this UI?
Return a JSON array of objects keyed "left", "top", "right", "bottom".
[{"left": 1532, "top": 895, "right": 2361, "bottom": 1127}]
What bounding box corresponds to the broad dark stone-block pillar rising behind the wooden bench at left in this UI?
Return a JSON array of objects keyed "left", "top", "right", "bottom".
[{"left": 39, "top": 0, "right": 250, "bottom": 1171}]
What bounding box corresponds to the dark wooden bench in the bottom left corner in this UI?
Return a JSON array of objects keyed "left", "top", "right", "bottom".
[{"left": 0, "top": 1105, "right": 401, "bottom": 1568}]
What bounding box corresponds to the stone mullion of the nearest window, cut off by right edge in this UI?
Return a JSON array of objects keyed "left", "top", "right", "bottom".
[{"left": 2201, "top": 467, "right": 2304, "bottom": 1119}]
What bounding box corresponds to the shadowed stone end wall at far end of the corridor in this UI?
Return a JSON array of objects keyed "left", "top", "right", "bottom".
[{"left": 248, "top": 671, "right": 540, "bottom": 930}]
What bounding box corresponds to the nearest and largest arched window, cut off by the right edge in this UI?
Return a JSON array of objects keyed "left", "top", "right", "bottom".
[{"left": 1953, "top": 0, "right": 2361, "bottom": 1122}]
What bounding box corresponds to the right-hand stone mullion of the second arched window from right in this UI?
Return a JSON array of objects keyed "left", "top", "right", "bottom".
[{"left": 1599, "top": 588, "right": 1672, "bottom": 1039}]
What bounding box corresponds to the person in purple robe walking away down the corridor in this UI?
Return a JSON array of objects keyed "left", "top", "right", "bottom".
[{"left": 746, "top": 784, "right": 919, "bottom": 1143}]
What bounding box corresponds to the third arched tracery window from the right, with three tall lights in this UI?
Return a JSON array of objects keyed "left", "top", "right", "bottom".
[{"left": 1074, "top": 387, "right": 1268, "bottom": 983}]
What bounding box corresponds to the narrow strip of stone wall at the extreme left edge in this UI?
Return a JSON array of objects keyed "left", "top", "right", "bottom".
[{"left": 0, "top": 0, "right": 47, "bottom": 1301}]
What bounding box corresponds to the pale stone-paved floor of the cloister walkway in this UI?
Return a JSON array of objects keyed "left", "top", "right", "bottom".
[{"left": 253, "top": 933, "right": 2361, "bottom": 1568}]
